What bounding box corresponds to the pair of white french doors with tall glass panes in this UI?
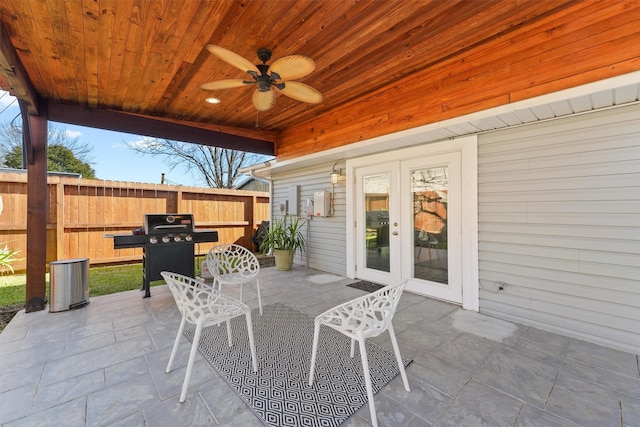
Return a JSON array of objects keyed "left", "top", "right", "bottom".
[{"left": 355, "top": 152, "right": 462, "bottom": 303}]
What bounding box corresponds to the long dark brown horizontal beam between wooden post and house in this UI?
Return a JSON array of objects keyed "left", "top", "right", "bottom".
[{"left": 48, "top": 103, "right": 275, "bottom": 155}]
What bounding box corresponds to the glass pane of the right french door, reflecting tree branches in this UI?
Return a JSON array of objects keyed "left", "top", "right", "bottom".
[{"left": 411, "top": 167, "right": 449, "bottom": 284}]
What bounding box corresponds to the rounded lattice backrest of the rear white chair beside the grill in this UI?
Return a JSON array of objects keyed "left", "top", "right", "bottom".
[{"left": 207, "top": 244, "right": 260, "bottom": 279}]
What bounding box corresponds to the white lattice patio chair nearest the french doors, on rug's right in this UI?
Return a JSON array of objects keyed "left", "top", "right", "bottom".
[{"left": 309, "top": 281, "right": 410, "bottom": 426}]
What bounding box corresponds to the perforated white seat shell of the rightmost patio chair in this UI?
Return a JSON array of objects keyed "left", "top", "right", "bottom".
[{"left": 318, "top": 280, "right": 407, "bottom": 338}]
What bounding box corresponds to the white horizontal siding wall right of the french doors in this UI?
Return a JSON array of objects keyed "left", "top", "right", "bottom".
[{"left": 478, "top": 105, "right": 640, "bottom": 354}]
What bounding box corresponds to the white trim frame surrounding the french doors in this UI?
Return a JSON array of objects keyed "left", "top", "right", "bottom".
[{"left": 346, "top": 135, "right": 480, "bottom": 311}]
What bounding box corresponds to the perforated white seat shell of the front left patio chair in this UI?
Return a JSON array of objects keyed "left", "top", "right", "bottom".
[{"left": 160, "top": 271, "right": 246, "bottom": 325}]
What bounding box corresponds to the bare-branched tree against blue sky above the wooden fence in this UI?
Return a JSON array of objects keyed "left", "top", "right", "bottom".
[{"left": 127, "top": 137, "right": 267, "bottom": 188}]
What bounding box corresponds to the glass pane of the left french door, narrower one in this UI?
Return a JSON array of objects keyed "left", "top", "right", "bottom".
[{"left": 363, "top": 173, "right": 390, "bottom": 272}]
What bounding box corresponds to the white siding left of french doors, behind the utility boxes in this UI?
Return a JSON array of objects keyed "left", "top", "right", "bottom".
[{"left": 271, "top": 164, "right": 346, "bottom": 276}]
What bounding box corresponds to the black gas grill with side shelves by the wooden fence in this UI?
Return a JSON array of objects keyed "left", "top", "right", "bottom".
[{"left": 113, "top": 214, "right": 218, "bottom": 298}]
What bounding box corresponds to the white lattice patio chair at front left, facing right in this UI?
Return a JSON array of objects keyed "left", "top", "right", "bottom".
[{"left": 160, "top": 271, "right": 258, "bottom": 403}]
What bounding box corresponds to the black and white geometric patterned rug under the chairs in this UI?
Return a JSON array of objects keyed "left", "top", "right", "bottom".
[{"left": 184, "top": 304, "right": 411, "bottom": 427}]
